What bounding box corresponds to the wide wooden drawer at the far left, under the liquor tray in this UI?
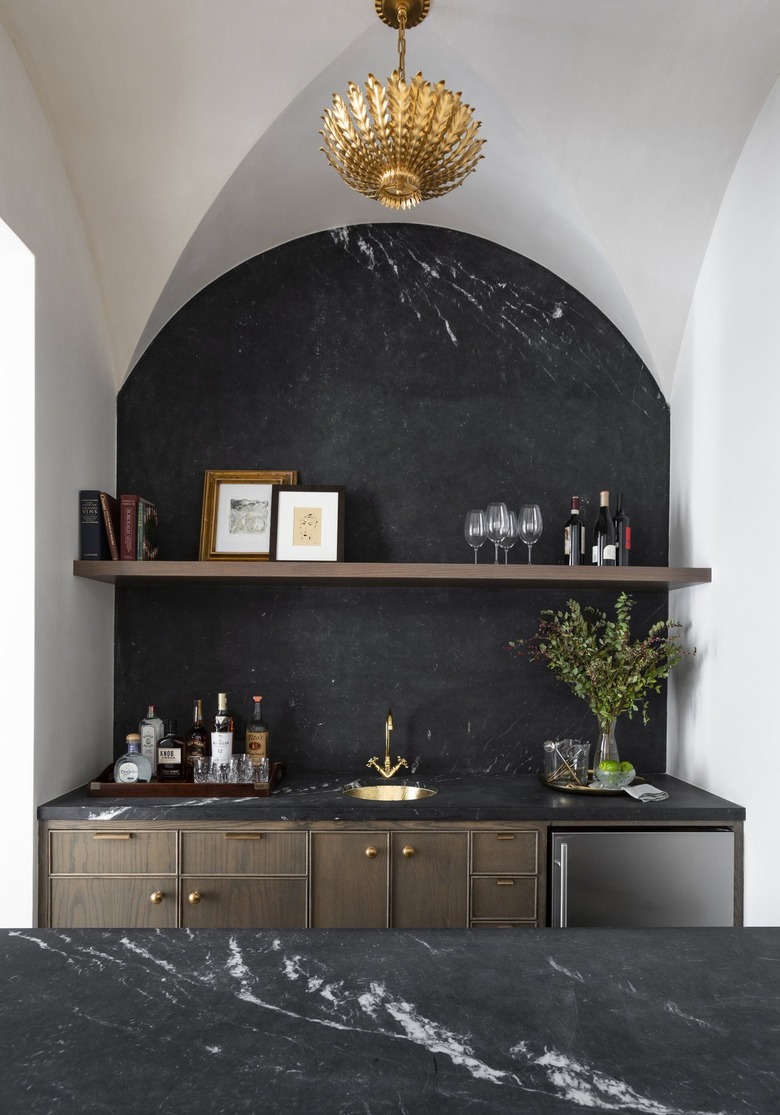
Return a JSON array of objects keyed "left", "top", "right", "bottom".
[{"left": 49, "top": 827, "right": 176, "bottom": 875}]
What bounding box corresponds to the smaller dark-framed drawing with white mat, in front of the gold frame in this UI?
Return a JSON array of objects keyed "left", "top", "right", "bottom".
[{"left": 271, "top": 484, "right": 344, "bottom": 561}]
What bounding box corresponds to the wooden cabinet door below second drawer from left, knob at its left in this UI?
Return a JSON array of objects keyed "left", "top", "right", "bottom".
[{"left": 182, "top": 875, "right": 306, "bottom": 929}]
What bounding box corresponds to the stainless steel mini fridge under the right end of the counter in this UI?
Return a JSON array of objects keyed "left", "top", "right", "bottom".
[{"left": 549, "top": 830, "right": 734, "bottom": 929}]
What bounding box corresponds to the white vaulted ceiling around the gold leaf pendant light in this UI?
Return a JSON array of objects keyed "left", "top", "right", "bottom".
[{"left": 0, "top": 0, "right": 780, "bottom": 395}]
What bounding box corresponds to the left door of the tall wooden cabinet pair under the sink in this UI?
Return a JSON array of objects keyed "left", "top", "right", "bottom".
[{"left": 311, "top": 832, "right": 388, "bottom": 929}]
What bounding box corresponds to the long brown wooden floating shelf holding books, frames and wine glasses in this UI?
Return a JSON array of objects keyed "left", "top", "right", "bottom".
[{"left": 74, "top": 561, "right": 712, "bottom": 592}]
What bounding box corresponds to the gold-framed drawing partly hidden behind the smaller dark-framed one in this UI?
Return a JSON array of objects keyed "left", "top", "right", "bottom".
[{"left": 198, "top": 471, "right": 298, "bottom": 561}]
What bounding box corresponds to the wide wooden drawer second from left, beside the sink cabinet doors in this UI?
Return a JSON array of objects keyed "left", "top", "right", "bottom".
[{"left": 182, "top": 828, "right": 306, "bottom": 875}]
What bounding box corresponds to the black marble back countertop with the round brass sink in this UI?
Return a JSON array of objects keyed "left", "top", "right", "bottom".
[{"left": 38, "top": 772, "right": 744, "bottom": 824}]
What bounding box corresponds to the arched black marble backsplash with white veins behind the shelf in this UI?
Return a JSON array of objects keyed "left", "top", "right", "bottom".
[{"left": 115, "top": 224, "right": 669, "bottom": 773}]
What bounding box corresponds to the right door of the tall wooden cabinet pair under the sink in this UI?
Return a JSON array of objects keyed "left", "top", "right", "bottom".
[{"left": 391, "top": 831, "right": 468, "bottom": 929}]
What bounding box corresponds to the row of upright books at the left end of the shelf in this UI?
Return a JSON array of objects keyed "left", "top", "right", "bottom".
[{"left": 79, "top": 491, "right": 157, "bottom": 561}]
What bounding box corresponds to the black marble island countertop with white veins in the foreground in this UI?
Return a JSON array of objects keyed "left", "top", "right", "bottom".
[{"left": 0, "top": 929, "right": 780, "bottom": 1115}]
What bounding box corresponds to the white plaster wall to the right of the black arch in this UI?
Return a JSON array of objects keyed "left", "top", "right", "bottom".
[{"left": 669, "top": 71, "right": 780, "bottom": 925}]
